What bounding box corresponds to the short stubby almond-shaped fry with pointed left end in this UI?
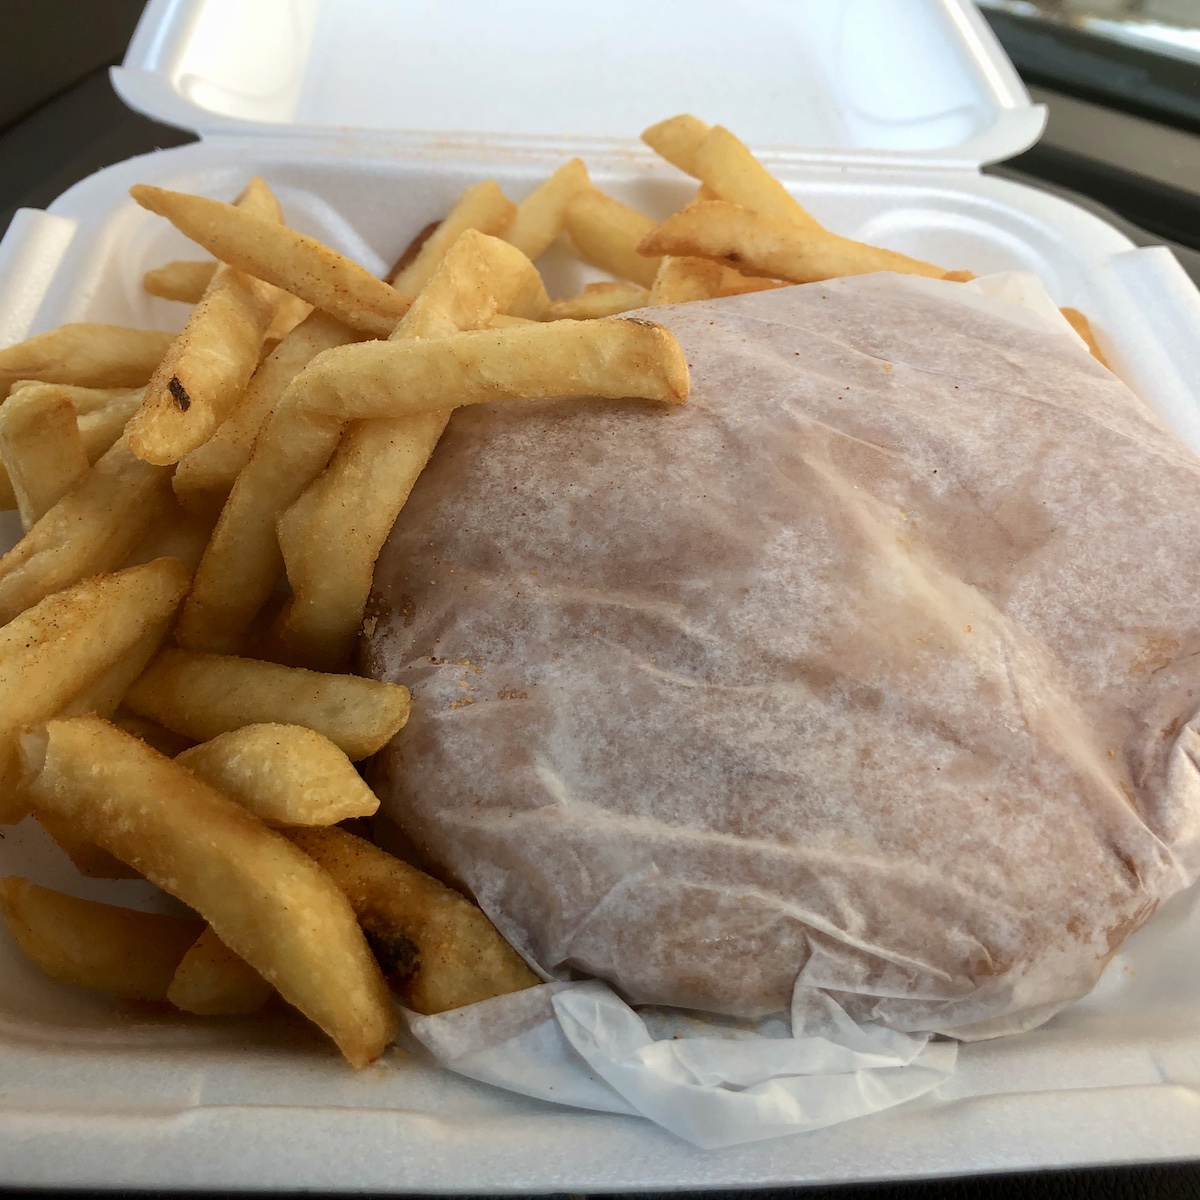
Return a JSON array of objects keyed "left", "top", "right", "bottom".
[{"left": 175, "top": 724, "right": 379, "bottom": 826}]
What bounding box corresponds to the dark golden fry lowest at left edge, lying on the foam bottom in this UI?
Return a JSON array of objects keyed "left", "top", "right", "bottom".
[{"left": 0, "top": 876, "right": 204, "bottom": 1000}]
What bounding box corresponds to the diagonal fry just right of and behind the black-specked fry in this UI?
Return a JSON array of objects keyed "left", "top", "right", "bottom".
[{"left": 172, "top": 311, "right": 359, "bottom": 516}]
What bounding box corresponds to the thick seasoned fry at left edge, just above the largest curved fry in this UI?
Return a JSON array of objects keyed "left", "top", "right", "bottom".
[{"left": 0, "top": 558, "right": 187, "bottom": 823}]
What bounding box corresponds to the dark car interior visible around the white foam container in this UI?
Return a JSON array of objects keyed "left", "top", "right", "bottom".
[{"left": 0, "top": 0, "right": 1200, "bottom": 1200}]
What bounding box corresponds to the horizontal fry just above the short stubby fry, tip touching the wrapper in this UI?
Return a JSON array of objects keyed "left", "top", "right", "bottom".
[{"left": 125, "top": 648, "right": 409, "bottom": 762}]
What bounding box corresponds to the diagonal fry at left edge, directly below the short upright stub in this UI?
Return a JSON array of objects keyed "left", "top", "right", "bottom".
[{"left": 0, "top": 438, "right": 174, "bottom": 623}]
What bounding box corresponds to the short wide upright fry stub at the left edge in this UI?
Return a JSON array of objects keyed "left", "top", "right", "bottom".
[{"left": 0, "top": 388, "right": 89, "bottom": 533}]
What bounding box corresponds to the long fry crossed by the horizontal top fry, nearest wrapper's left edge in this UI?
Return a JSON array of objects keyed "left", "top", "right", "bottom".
[{"left": 275, "top": 229, "right": 548, "bottom": 671}]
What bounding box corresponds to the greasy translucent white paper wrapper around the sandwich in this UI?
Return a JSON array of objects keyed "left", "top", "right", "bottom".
[{"left": 367, "top": 276, "right": 1200, "bottom": 1146}]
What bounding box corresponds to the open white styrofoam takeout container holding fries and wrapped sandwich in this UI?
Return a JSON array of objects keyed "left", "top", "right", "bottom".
[{"left": 0, "top": 0, "right": 1200, "bottom": 1192}]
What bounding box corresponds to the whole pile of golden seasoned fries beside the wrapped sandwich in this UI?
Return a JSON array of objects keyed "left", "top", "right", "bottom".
[{"left": 0, "top": 115, "right": 1104, "bottom": 1066}]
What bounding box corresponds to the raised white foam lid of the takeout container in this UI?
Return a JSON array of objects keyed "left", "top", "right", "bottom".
[{"left": 113, "top": 0, "right": 1045, "bottom": 168}]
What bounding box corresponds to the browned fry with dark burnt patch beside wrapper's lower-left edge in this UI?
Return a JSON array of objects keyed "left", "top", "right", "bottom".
[{"left": 287, "top": 828, "right": 539, "bottom": 1013}]
